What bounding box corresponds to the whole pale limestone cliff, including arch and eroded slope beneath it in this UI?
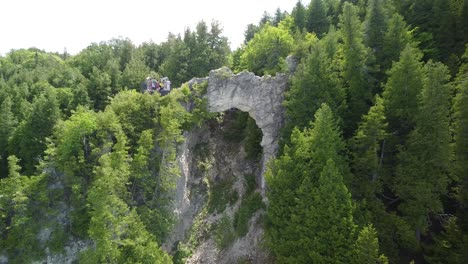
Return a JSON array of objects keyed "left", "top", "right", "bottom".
[{"left": 164, "top": 68, "right": 288, "bottom": 263}]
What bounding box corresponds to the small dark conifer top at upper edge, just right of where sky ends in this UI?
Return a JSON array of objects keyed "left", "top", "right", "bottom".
[{"left": 307, "top": 0, "right": 330, "bottom": 38}]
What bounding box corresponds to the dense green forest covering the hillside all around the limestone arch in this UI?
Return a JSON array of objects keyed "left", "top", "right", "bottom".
[{"left": 0, "top": 0, "right": 468, "bottom": 263}]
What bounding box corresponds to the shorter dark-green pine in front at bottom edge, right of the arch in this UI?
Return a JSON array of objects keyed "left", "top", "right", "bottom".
[{"left": 290, "top": 159, "right": 356, "bottom": 263}]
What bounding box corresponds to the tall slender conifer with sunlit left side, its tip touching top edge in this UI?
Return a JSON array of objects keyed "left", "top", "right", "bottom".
[{"left": 340, "top": 3, "right": 373, "bottom": 136}]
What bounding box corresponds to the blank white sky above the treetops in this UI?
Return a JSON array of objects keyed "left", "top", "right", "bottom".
[{"left": 0, "top": 0, "right": 300, "bottom": 55}]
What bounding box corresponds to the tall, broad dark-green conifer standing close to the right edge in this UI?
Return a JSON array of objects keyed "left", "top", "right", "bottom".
[{"left": 394, "top": 62, "right": 452, "bottom": 245}]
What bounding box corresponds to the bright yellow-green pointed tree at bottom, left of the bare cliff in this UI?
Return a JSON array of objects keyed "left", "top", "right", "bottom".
[{"left": 81, "top": 151, "right": 171, "bottom": 263}]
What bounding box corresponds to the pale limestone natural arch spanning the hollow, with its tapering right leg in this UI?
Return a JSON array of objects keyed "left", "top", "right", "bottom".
[{"left": 206, "top": 68, "right": 288, "bottom": 190}]
